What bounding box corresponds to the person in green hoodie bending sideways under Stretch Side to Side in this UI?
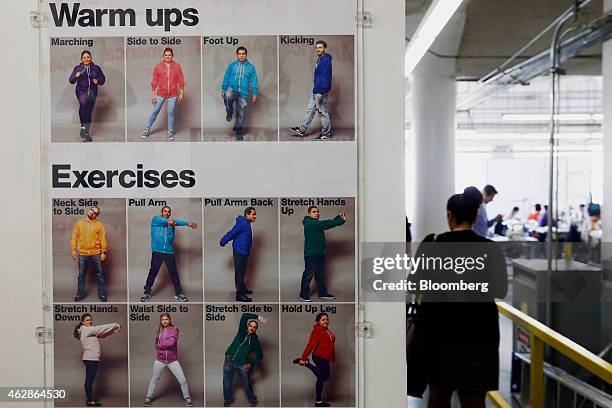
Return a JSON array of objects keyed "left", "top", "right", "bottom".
[{"left": 223, "top": 313, "right": 266, "bottom": 407}]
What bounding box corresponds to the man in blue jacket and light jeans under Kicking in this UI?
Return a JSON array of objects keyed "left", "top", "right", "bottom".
[{"left": 289, "top": 40, "right": 332, "bottom": 140}]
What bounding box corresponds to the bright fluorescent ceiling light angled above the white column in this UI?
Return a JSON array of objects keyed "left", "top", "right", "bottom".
[{"left": 405, "top": 0, "right": 463, "bottom": 77}]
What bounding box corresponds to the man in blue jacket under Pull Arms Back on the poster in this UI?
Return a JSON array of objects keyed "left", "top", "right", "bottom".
[{"left": 219, "top": 207, "right": 257, "bottom": 302}]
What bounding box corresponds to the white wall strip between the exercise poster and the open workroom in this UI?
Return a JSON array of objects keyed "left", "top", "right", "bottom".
[{"left": 360, "top": 0, "right": 406, "bottom": 407}]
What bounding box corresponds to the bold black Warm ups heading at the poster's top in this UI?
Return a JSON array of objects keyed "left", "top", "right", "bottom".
[{"left": 49, "top": 3, "right": 200, "bottom": 31}]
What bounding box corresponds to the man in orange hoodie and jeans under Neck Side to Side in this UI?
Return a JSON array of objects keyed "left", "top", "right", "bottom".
[{"left": 70, "top": 207, "right": 108, "bottom": 302}]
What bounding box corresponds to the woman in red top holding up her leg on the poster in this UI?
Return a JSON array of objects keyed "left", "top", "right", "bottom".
[{"left": 293, "top": 313, "right": 336, "bottom": 407}]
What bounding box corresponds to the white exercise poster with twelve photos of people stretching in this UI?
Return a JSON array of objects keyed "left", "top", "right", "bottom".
[{"left": 41, "top": 0, "right": 358, "bottom": 407}]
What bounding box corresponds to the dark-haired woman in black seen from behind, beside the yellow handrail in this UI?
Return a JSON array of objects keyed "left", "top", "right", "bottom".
[{"left": 408, "top": 187, "right": 508, "bottom": 408}]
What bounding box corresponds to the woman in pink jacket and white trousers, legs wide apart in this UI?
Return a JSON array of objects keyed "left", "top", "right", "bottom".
[{"left": 144, "top": 313, "right": 193, "bottom": 407}]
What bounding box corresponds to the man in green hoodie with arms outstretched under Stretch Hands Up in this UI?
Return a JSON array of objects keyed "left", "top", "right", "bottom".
[{"left": 300, "top": 205, "right": 346, "bottom": 302}]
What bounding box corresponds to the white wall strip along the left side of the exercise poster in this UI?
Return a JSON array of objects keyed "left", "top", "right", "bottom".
[{"left": 0, "top": 0, "right": 43, "bottom": 396}]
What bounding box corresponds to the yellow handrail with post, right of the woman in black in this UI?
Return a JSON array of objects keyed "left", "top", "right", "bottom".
[{"left": 487, "top": 302, "right": 612, "bottom": 408}]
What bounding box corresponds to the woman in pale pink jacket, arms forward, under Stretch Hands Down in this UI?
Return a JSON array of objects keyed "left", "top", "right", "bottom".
[{"left": 73, "top": 313, "right": 121, "bottom": 407}]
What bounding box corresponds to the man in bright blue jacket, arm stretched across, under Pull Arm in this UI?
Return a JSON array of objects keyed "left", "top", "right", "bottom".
[{"left": 140, "top": 206, "right": 198, "bottom": 302}]
